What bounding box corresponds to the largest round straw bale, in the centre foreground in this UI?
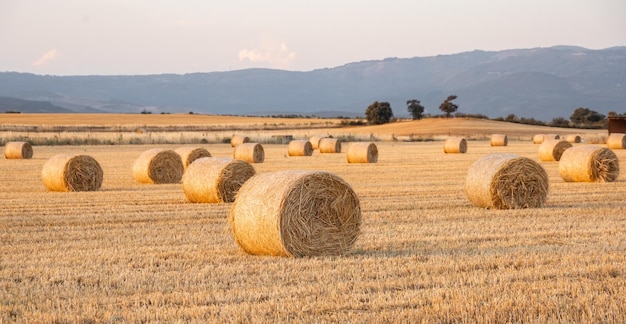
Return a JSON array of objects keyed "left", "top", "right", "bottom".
[{"left": 229, "top": 170, "right": 361, "bottom": 257}]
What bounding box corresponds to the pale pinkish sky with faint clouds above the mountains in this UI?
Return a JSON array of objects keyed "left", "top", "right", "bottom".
[{"left": 0, "top": 0, "right": 626, "bottom": 75}]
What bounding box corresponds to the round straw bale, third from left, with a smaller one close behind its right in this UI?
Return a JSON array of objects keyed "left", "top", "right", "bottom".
[{"left": 133, "top": 148, "right": 185, "bottom": 184}]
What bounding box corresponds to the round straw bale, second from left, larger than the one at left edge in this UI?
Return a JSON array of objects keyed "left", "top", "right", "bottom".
[{"left": 41, "top": 153, "right": 104, "bottom": 192}]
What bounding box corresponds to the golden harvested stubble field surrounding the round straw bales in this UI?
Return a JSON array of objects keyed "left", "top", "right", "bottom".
[{"left": 0, "top": 115, "right": 626, "bottom": 323}]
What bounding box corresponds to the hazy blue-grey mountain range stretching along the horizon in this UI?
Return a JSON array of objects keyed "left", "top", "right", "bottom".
[{"left": 0, "top": 46, "right": 626, "bottom": 121}]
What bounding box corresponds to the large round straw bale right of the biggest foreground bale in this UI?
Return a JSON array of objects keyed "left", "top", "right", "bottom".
[{"left": 465, "top": 153, "right": 548, "bottom": 209}]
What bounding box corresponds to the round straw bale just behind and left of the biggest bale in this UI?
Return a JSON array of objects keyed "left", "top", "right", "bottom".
[{"left": 183, "top": 157, "right": 255, "bottom": 203}]
